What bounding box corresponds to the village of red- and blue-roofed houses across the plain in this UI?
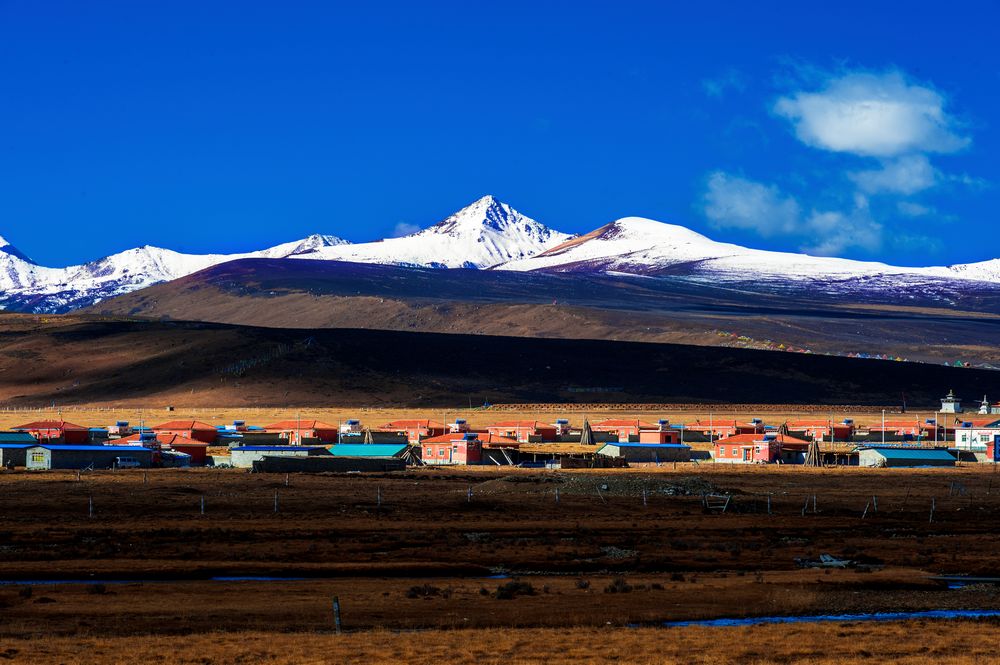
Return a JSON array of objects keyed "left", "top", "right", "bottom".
[{"left": 0, "top": 391, "right": 1000, "bottom": 473}]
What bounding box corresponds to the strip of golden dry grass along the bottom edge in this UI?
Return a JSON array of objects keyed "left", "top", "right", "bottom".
[{"left": 11, "top": 621, "right": 998, "bottom": 665}]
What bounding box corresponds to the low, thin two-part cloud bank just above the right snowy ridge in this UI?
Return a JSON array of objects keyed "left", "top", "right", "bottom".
[{"left": 702, "top": 171, "right": 883, "bottom": 256}]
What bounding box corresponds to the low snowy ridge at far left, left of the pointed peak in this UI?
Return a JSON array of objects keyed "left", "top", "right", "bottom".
[{"left": 0, "top": 235, "right": 347, "bottom": 312}]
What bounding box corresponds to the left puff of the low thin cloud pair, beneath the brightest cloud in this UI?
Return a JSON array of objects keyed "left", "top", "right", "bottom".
[{"left": 703, "top": 171, "right": 800, "bottom": 236}]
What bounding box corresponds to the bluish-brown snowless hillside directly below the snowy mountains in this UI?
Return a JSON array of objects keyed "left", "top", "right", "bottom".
[{"left": 90, "top": 260, "right": 1000, "bottom": 365}]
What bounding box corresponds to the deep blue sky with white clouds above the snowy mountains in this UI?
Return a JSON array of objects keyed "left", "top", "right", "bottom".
[{"left": 0, "top": 0, "right": 1000, "bottom": 265}]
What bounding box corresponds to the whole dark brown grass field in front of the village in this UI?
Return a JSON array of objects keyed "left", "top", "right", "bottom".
[{"left": 0, "top": 464, "right": 1000, "bottom": 663}]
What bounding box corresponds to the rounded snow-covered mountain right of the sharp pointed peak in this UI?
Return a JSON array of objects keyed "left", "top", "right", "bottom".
[{"left": 498, "top": 217, "right": 959, "bottom": 281}]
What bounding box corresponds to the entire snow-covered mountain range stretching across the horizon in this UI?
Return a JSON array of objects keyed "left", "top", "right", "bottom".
[{"left": 0, "top": 196, "right": 1000, "bottom": 312}]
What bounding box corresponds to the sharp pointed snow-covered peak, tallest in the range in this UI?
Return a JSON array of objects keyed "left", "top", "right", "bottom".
[{"left": 299, "top": 196, "right": 570, "bottom": 268}]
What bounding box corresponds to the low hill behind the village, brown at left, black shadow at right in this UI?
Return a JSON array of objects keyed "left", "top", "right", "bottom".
[{"left": 0, "top": 315, "right": 1000, "bottom": 406}]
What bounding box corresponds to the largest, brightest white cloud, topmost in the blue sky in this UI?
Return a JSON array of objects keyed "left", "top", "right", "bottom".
[{"left": 774, "top": 71, "right": 970, "bottom": 157}]
